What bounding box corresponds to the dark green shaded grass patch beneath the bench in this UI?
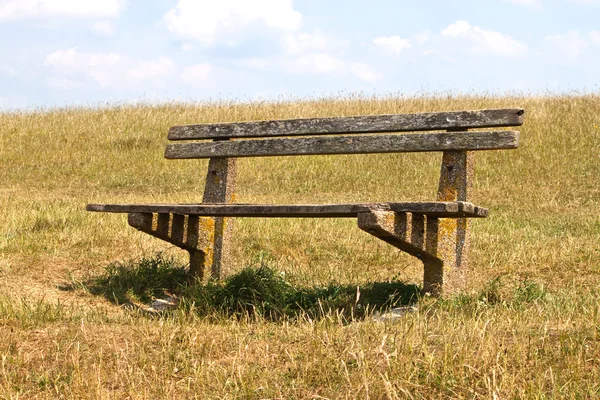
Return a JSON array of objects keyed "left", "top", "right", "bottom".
[{"left": 76, "top": 254, "right": 419, "bottom": 320}]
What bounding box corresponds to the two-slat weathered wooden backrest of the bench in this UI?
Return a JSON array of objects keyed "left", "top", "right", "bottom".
[{"left": 165, "top": 108, "right": 524, "bottom": 159}]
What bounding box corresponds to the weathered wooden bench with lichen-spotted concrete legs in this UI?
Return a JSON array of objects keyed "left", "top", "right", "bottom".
[{"left": 87, "top": 108, "right": 524, "bottom": 295}]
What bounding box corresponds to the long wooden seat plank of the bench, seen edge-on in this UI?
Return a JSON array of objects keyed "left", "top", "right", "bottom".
[{"left": 86, "top": 202, "right": 487, "bottom": 218}]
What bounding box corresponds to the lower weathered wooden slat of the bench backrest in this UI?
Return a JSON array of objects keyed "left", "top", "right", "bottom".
[{"left": 165, "top": 131, "right": 519, "bottom": 159}]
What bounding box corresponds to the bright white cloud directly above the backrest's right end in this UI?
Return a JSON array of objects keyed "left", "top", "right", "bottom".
[{"left": 442, "top": 21, "right": 527, "bottom": 56}]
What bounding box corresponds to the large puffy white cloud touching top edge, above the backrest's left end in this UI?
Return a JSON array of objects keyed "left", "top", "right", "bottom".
[{"left": 164, "top": 0, "right": 302, "bottom": 45}]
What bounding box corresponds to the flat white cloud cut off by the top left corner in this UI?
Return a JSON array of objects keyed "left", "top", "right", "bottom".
[{"left": 0, "top": 0, "right": 124, "bottom": 20}]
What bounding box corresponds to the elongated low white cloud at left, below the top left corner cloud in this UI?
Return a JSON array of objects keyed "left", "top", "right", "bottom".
[{"left": 44, "top": 48, "right": 176, "bottom": 87}]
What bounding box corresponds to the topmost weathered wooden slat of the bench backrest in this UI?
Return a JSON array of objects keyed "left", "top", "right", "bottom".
[{"left": 169, "top": 108, "right": 524, "bottom": 140}]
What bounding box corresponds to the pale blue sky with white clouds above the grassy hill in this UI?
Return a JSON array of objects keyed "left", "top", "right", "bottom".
[{"left": 0, "top": 0, "right": 600, "bottom": 110}]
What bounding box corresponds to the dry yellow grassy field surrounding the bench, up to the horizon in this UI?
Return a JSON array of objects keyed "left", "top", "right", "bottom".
[{"left": 0, "top": 95, "right": 600, "bottom": 399}]
